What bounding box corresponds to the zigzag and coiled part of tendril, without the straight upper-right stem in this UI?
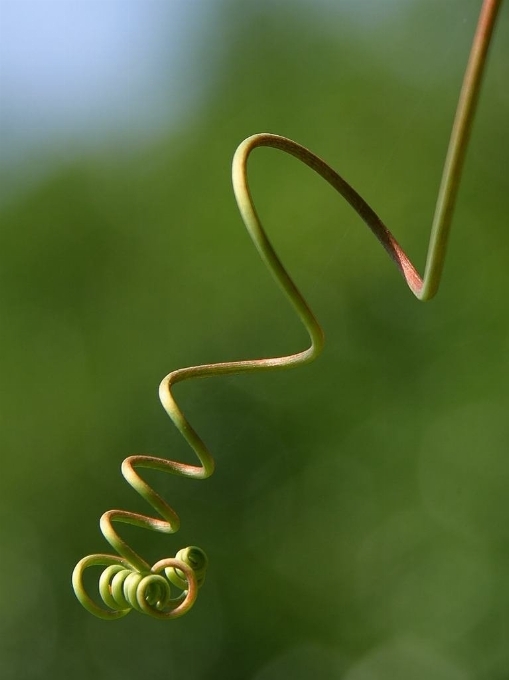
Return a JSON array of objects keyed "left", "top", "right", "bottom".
[{"left": 73, "top": 134, "right": 430, "bottom": 618}]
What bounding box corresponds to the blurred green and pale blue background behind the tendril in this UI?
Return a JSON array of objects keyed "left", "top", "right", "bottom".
[{"left": 0, "top": 0, "right": 509, "bottom": 680}]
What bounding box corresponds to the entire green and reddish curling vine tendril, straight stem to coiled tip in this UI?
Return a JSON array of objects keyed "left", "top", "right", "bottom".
[{"left": 72, "top": 0, "right": 501, "bottom": 619}]
